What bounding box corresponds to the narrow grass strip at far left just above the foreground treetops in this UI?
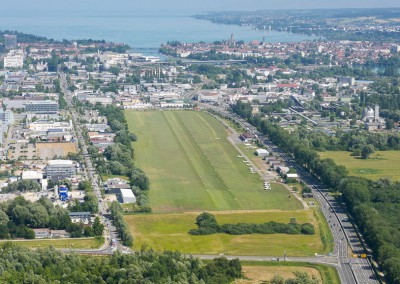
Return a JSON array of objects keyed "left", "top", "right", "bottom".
[{"left": 1, "top": 238, "right": 104, "bottom": 249}]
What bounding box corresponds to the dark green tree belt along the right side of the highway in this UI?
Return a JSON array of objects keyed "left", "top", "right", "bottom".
[{"left": 233, "top": 102, "right": 400, "bottom": 283}]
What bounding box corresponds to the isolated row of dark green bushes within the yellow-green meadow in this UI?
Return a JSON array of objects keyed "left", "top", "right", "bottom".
[{"left": 189, "top": 212, "right": 315, "bottom": 235}]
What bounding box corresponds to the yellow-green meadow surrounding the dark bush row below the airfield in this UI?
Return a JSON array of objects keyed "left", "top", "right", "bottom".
[{"left": 125, "top": 210, "right": 325, "bottom": 257}]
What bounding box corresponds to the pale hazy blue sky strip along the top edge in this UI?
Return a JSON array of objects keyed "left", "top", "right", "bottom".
[{"left": 5, "top": 0, "right": 400, "bottom": 14}]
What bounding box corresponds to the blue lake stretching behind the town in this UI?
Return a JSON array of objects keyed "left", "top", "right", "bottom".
[{"left": 0, "top": 12, "right": 314, "bottom": 48}]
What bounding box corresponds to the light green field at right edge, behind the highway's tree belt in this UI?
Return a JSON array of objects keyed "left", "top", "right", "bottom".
[{"left": 319, "top": 151, "right": 400, "bottom": 181}]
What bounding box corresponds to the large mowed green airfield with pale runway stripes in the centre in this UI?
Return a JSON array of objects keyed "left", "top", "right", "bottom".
[{"left": 126, "top": 111, "right": 302, "bottom": 213}]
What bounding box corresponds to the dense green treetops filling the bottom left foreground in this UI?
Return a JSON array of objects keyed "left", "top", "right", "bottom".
[{"left": 0, "top": 243, "right": 243, "bottom": 284}]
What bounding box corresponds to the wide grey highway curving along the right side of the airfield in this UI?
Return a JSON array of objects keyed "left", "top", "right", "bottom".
[{"left": 198, "top": 103, "right": 378, "bottom": 284}]
